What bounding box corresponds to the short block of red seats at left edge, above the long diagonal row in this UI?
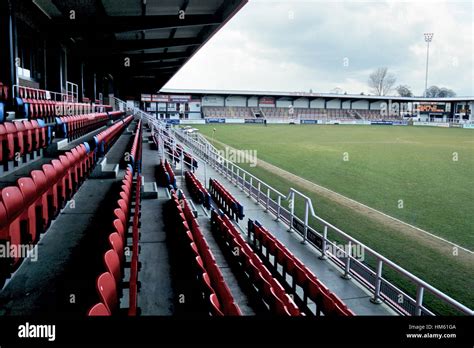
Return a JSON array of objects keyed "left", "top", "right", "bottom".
[{"left": 0, "top": 120, "right": 51, "bottom": 163}]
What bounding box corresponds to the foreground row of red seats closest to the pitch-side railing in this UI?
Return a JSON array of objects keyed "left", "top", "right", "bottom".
[{"left": 248, "top": 219, "right": 354, "bottom": 316}]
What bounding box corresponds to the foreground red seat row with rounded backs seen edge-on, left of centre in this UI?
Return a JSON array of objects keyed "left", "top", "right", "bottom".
[{"left": 88, "top": 166, "right": 141, "bottom": 316}]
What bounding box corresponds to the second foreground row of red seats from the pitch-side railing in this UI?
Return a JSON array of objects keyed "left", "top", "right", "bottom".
[{"left": 211, "top": 210, "right": 304, "bottom": 316}]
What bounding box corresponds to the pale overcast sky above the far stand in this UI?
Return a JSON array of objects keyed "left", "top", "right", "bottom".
[{"left": 165, "top": 0, "right": 474, "bottom": 96}]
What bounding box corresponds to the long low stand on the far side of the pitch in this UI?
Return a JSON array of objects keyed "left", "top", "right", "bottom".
[{"left": 141, "top": 89, "right": 474, "bottom": 124}]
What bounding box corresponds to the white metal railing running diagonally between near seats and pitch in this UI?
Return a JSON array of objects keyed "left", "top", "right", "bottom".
[{"left": 137, "top": 110, "right": 474, "bottom": 315}]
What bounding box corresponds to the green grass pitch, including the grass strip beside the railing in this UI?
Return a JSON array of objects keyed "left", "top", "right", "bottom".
[{"left": 197, "top": 125, "right": 474, "bottom": 311}]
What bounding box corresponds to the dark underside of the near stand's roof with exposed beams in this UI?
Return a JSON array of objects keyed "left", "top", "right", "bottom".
[{"left": 33, "top": 0, "right": 248, "bottom": 94}]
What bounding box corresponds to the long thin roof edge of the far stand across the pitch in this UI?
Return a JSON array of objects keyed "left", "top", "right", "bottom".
[{"left": 160, "top": 88, "right": 474, "bottom": 102}]
